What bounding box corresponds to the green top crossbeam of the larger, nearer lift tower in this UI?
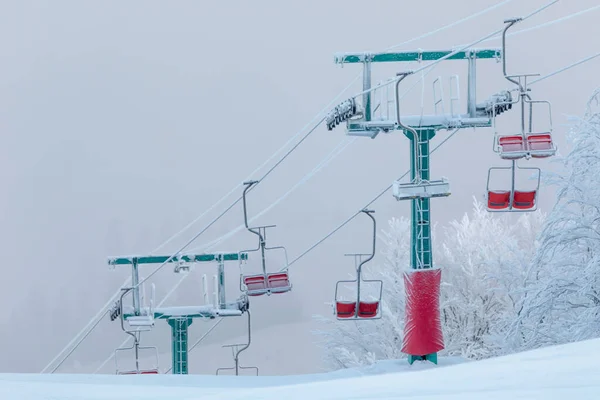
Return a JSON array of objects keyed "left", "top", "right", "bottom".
[{"left": 335, "top": 49, "right": 502, "bottom": 64}]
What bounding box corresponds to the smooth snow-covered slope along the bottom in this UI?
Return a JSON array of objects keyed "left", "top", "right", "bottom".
[{"left": 0, "top": 339, "right": 600, "bottom": 400}]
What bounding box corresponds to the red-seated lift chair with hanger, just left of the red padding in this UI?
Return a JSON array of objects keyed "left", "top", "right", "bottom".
[{"left": 334, "top": 210, "right": 383, "bottom": 321}]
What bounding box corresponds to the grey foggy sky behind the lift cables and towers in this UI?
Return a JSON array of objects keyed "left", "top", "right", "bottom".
[{"left": 0, "top": 0, "right": 599, "bottom": 373}]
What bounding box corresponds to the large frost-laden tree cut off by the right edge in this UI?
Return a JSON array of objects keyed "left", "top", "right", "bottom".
[{"left": 512, "top": 89, "right": 600, "bottom": 349}]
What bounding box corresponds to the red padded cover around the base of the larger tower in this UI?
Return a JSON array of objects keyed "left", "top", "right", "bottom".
[{"left": 402, "top": 269, "right": 444, "bottom": 356}]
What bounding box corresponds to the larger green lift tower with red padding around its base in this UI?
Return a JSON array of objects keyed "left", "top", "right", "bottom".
[{"left": 326, "top": 43, "right": 511, "bottom": 364}]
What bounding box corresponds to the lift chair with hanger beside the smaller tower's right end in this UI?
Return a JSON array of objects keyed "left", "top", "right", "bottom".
[{"left": 238, "top": 181, "right": 292, "bottom": 296}]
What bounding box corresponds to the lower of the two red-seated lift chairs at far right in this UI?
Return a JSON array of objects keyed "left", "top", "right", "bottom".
[{"left": 486, "top": 161, "right": 541, "bottom": 212}]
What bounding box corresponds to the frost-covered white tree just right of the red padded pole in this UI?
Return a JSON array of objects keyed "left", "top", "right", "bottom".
[{"left": 437, "top": 200, "right": 544, "bottom": 359}]
